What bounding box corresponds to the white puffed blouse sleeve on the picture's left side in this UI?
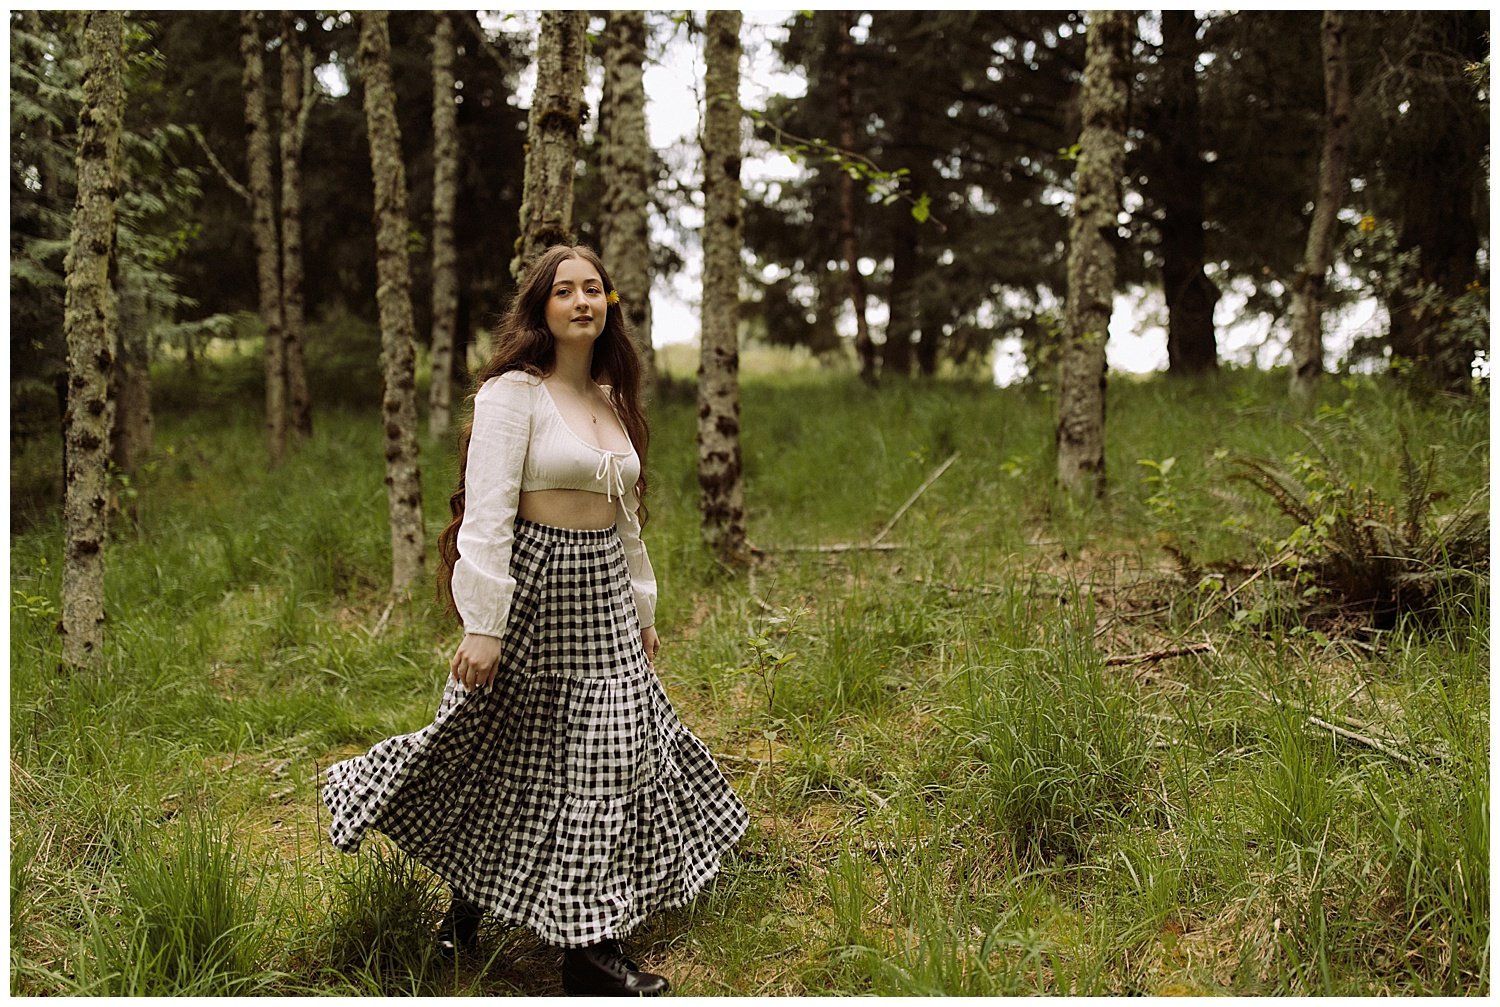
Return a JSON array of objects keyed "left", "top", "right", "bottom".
[{"left": 453, "top": 371, "right": 537, "bottom": 636}]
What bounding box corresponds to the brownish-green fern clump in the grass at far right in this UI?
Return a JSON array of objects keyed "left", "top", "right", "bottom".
[{"left": 1232, "top": 435, "right": 1490, "bottom": 627}]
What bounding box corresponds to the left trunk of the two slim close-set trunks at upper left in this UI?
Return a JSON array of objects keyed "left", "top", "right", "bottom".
[{"left": 240, "top": 11, "right": 287, "bottom": 468}]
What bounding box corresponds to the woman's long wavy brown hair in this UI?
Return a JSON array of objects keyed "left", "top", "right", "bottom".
[{"left": 438, "top": 245, "right": 651, "bottom": 615}]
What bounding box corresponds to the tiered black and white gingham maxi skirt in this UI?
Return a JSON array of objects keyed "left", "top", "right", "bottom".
[{"left": 323, "top": 519, "right": 749, "bottom": 947}]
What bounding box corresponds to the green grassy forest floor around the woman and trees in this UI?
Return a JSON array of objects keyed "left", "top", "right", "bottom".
[{"left": 11, "top": 358, "right": 1490, "bottom": 995}]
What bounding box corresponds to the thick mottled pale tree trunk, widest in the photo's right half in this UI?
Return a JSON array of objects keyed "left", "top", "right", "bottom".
[{"left": 1058, "top": 11, "right": 1134, "bottom": 497}]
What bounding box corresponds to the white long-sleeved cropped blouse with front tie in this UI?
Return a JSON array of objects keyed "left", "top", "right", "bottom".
[{"left": 453, "top": 371, "right": 657, "bottom": 636}]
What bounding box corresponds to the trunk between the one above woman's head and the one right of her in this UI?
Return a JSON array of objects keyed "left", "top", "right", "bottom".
[{"left": 600, "top": 11, "right": 657, "bottom": 401}]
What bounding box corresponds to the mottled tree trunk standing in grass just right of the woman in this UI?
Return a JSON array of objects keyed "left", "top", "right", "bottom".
[{"left": 698, "top": 11, "right": 749, "bottom": 566}]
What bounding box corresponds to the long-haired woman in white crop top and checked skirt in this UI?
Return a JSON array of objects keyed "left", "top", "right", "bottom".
[{"left": 323, "top": 246, "right": 749, "bottom": 995}]
